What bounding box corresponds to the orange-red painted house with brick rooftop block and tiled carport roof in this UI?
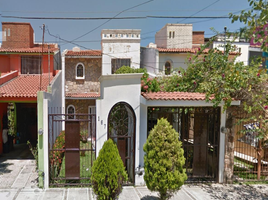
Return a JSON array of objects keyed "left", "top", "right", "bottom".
[{"left": 0, "top": 22, "right": 61, "bottom": 154}]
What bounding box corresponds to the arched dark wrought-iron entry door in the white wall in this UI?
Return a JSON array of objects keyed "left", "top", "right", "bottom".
[{"left": 108, "top": 102, "right": 136, "bottom": 183}]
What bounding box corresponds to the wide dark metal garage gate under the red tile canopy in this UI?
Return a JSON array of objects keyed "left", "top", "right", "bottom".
[{"left": 148, "top": 107, "right": 220, "bottom": 182}]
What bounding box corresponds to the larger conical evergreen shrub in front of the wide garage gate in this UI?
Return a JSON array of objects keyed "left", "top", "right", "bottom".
[{"left": 143, "top": 118, "right": 187, "bottom": 199}]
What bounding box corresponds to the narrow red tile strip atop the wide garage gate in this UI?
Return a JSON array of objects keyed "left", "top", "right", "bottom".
[{"left": 141, "top": 92, "right": 213, "bottom": 101}]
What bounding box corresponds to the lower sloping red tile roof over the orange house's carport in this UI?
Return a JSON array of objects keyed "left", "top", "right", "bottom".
[{"left": 0, "top": 74, "right": 53, "bottom": 98}]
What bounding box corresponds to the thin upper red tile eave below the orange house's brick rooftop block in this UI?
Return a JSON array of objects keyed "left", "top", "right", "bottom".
[{"left": 0, "top": 44, "right": 59, "bottom": 53}]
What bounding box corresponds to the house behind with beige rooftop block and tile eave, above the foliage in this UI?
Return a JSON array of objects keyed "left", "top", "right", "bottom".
[{"left": 141, "top": 24, "right": 207, "bottom": 76}]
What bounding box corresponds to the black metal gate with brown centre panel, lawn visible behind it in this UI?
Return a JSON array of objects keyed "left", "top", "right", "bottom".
[{"left": 48, "top": 114, "right": 96, "bottom": 186}]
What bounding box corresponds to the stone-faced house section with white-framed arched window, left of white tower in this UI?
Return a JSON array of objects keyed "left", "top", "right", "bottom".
[{"left": 62, "top": 47, "right": 102, "bottom": 138}]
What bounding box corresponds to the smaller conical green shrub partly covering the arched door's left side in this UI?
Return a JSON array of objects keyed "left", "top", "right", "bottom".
[{"left": 91, "top": 139, "right": 127, "bottom": 200}]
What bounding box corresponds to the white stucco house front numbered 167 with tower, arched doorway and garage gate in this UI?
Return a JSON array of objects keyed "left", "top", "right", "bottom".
[{"left": 93, "top": 30, "right": 239, "bottom": 185}]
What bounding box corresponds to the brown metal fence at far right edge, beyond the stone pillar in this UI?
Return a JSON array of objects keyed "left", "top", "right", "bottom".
[{"left": 232, "top": 108, "right": 268, "bottom": 182}]
